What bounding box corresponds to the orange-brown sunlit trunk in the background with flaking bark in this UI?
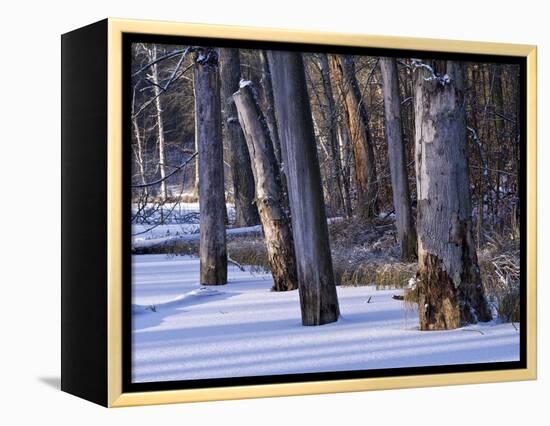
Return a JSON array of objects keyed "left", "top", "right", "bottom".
[{"left": 329, "top": 55, "right": 378, "bottom": 218}]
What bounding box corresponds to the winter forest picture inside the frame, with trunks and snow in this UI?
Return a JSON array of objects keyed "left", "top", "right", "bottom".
[{"left": 129, "top": 43, "right": 524, "bottom": 382}]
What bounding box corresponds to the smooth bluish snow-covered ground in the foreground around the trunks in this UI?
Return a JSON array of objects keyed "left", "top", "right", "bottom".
[{"left": 132, "top": 255, "right": 519, "bottom": 382}]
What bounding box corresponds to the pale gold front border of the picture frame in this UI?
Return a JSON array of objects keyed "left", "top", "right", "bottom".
[{"left": 61, "top": 18, "right": 537, "bottom": 407}]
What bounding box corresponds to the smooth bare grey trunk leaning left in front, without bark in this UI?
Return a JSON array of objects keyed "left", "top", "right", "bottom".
[{"left": 268, "top": 51, "right": 340, "bottom": 325}]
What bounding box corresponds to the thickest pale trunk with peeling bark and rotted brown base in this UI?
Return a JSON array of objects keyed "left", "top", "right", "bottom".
[{"left": 414, "top": 61, "right": 491, "bottom": 330}]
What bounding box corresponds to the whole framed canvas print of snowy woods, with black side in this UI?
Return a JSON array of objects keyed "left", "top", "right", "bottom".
[{"left": 62, "top": 19, "right": 536, "bottom": 407}]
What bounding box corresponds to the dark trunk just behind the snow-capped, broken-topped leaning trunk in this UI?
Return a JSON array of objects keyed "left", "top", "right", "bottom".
[{"left": 219, "top": 48, "right": 260, "bottom": 227}]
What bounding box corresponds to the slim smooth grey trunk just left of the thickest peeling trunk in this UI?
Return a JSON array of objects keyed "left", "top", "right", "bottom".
[{"left": 380, "top": 58, "right": 416, "bottom": 261}]
